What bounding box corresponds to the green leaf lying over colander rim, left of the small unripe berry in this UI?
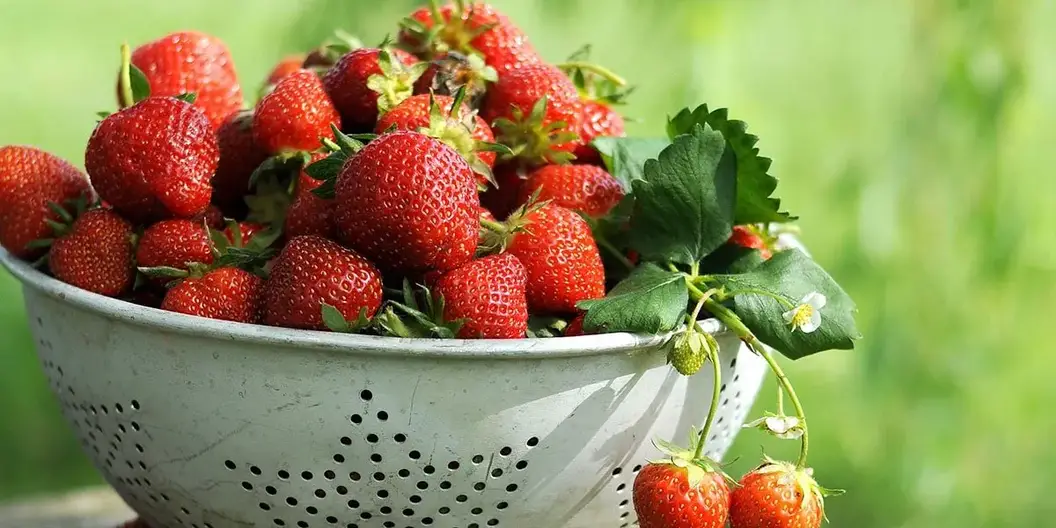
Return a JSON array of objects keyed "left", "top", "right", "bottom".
[{"left": 578, "top": 263, "right": 690, "bottom": 334}]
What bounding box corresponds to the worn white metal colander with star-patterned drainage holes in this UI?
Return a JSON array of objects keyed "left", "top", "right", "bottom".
[{"left": 0, "top": 251, "right": 766, "bottom": 528}]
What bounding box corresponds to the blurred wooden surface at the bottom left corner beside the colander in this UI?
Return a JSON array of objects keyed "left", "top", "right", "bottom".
[{"left": 0, "top": 488, "right": 135, "bottom": 528}]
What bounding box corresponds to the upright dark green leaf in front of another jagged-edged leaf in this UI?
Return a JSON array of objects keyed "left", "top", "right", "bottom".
[{"left": 630, "top": 125, "right": 737, "bottom": 264}]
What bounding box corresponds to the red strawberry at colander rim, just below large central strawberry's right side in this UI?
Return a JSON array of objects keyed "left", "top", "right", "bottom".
[{"left": 433, "top": 253, "right": 528, "bottom": 339}]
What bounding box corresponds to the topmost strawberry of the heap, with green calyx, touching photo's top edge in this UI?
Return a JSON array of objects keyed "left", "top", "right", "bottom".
[{"left": 399, "top": 0, "right": 542, "bottom": 75}]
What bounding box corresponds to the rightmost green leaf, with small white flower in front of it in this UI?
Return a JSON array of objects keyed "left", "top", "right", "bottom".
[{"left": 715, "top": 249, "right": 862, "bottom": 359}]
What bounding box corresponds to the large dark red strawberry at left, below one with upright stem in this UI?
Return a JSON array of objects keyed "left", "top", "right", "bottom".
[{"left": 84, "top": 97, "right": 220, "bottom": 224}]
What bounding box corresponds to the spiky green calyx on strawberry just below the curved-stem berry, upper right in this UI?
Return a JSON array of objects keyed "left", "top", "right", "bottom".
[{"left": 493, "top": 96, "right": 580, "bottom": 167}]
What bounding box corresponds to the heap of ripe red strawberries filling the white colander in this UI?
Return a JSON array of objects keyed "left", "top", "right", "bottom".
[{"left": 0, "top": 2, "right": 675, "bottom": 338}]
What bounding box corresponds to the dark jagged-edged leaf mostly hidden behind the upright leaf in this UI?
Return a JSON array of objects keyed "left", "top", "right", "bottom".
[{"left": 667, "top": 105, "right": 796, "bottom": 225}]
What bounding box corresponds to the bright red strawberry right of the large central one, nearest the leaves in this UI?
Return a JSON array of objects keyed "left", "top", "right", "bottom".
[{"left": 507, "top": 204, "right": 605, "bottom": 315}]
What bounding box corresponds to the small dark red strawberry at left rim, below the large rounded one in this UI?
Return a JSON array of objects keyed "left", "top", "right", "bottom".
[{"left": 48, "top": 209, "right": 135, "bottom": 297}]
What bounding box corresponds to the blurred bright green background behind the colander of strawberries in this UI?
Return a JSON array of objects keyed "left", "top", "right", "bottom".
[{"left": 0, "top": 0, "right": 1056, "bottom": 528}]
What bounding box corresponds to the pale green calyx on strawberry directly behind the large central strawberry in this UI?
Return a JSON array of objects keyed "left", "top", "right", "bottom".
[{"left": 418, "top": 87, "right": 513, "bottom": 190}]
